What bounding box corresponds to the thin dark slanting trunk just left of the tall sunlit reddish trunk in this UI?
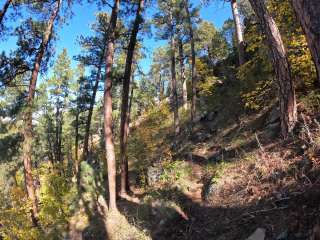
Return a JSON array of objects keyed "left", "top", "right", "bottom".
[{"left": 82, "top": 54, "right": 105, "bottom": 161}]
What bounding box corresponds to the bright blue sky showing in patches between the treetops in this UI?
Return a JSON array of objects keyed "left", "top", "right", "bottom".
[{"left": 0, "top": 0, "right": 231, "bottom": 72}]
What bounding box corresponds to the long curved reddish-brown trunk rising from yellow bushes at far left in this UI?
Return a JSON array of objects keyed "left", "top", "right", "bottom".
[{"left": 23, "top": 0, "right": 61, "bottom": 225}]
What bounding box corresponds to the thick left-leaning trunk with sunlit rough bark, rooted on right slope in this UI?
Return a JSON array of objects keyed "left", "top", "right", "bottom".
[{"left": 250, "top": 0, "right": 297, "bottom": 139}]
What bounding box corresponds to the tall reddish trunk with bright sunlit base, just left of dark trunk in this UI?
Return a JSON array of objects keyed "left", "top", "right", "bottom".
[{"left": 104, "top": 0, "right": 120, "bottom": 210}]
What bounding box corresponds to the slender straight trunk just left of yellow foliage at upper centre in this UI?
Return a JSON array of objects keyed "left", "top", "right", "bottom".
[{"left": 185, "top": 0, "right": 197, "bottom": 123}]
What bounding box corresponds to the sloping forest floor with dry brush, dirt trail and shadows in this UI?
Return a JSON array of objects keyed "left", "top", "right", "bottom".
[{"left": 69, "top": 78, "right": 320, "bottom": 240}]
